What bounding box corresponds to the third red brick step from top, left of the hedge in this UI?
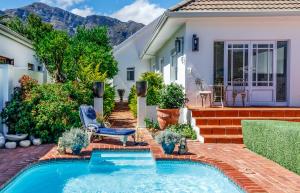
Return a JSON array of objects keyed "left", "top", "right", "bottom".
[{"left": 197, "top": 125, "right": 242, "bottom": 135}]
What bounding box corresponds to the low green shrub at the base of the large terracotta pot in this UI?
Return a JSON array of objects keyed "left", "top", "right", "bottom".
[{"left": 167, "top": 124, "right": 197, "bottom": 140}]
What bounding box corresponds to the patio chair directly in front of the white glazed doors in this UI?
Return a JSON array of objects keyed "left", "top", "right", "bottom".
[{"left": 232, "top": 78, "right": 247, "bottom": 107}]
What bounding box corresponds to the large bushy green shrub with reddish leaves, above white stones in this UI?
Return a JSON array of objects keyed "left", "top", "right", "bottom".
[{"left": 1, "top": 76, "right": 93, "bottom": 143}]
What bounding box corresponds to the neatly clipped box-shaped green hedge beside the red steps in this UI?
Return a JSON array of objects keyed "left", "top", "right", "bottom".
[{"left": 242, "top": 121, "right": 300, "bottom": 174}]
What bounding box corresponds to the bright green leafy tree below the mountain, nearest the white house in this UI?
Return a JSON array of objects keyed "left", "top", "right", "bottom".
[{"left": 67, "top": 27, "right": 118, "bottom": 79}]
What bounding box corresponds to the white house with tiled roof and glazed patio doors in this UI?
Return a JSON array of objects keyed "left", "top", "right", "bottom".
[{"left": 115, "top": 0, "right": 300, "bottom": 107}]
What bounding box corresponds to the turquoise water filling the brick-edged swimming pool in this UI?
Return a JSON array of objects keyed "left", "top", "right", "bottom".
[{"left": 0, "top": 151, "right": 242, "bottom": 193}]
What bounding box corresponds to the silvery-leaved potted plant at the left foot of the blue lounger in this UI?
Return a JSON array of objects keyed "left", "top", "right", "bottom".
[{"left": 58, "top": 128, "right": 89, "bottom": 155}]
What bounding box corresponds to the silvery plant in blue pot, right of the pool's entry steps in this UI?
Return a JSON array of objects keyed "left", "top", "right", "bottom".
[{"left": 155, "top": 130, "right": 181, "bottom": 154}]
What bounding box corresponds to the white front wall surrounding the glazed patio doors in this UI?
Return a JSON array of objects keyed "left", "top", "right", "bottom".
[{"left": 185, "top": 17, "right": 300, "bottom": 106}]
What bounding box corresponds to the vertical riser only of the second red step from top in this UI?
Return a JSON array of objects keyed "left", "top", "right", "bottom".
[{"left": 196, "top": 117, "right": 300, "bottom": 125}]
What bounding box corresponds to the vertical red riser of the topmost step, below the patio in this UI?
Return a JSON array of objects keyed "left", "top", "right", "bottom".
[{"left": 193, "top": 110, "right": 300, "bottom": 117}]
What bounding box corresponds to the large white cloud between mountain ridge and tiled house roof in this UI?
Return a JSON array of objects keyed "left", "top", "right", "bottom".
[{"left": 110, "top": 0, "right": 165, "bottom": 24}]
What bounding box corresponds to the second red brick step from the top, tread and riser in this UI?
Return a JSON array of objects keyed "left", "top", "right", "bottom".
[{"left": 195, "top": 117, "right": 300, "bottom": 125}]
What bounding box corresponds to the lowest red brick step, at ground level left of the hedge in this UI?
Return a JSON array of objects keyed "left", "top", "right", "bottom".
[{"left": 201, "top": 135, "right": 243, "bottom": 144}]
